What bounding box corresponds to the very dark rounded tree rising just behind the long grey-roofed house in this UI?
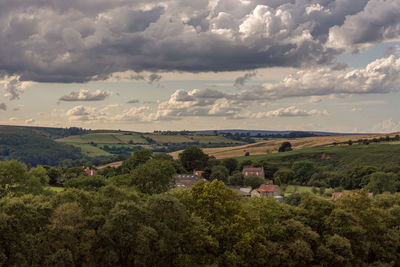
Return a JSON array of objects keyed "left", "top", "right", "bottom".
[{"left": 179, "top": 146, "right": 208, "bottom": 172}]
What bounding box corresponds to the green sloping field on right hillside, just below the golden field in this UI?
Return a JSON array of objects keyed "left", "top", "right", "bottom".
[{"left": 237, "top": 144, "right": 400, "bottom": 172}]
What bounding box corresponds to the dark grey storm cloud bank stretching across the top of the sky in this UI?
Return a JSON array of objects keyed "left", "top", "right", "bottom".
[{"left": 0, "top": 0, "right": 400, "bottom": 83}]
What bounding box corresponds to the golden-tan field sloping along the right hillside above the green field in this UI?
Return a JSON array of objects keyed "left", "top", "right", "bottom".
[{"left": 171, "top": 133, "right": 398, "bottom": 159}]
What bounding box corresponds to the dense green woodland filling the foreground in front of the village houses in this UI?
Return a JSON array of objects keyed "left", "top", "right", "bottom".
[{"left": 0, "top": 147, "right": 400, "bottom": 266}]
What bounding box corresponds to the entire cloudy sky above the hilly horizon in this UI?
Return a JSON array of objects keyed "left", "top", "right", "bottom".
[{"left": 0, "top": 0, "right": 400, "bottom": 132}]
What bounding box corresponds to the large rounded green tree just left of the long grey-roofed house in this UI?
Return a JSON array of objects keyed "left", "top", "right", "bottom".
[{"left": 130, "top": 159, "right": 175, "bottom": 194}]
